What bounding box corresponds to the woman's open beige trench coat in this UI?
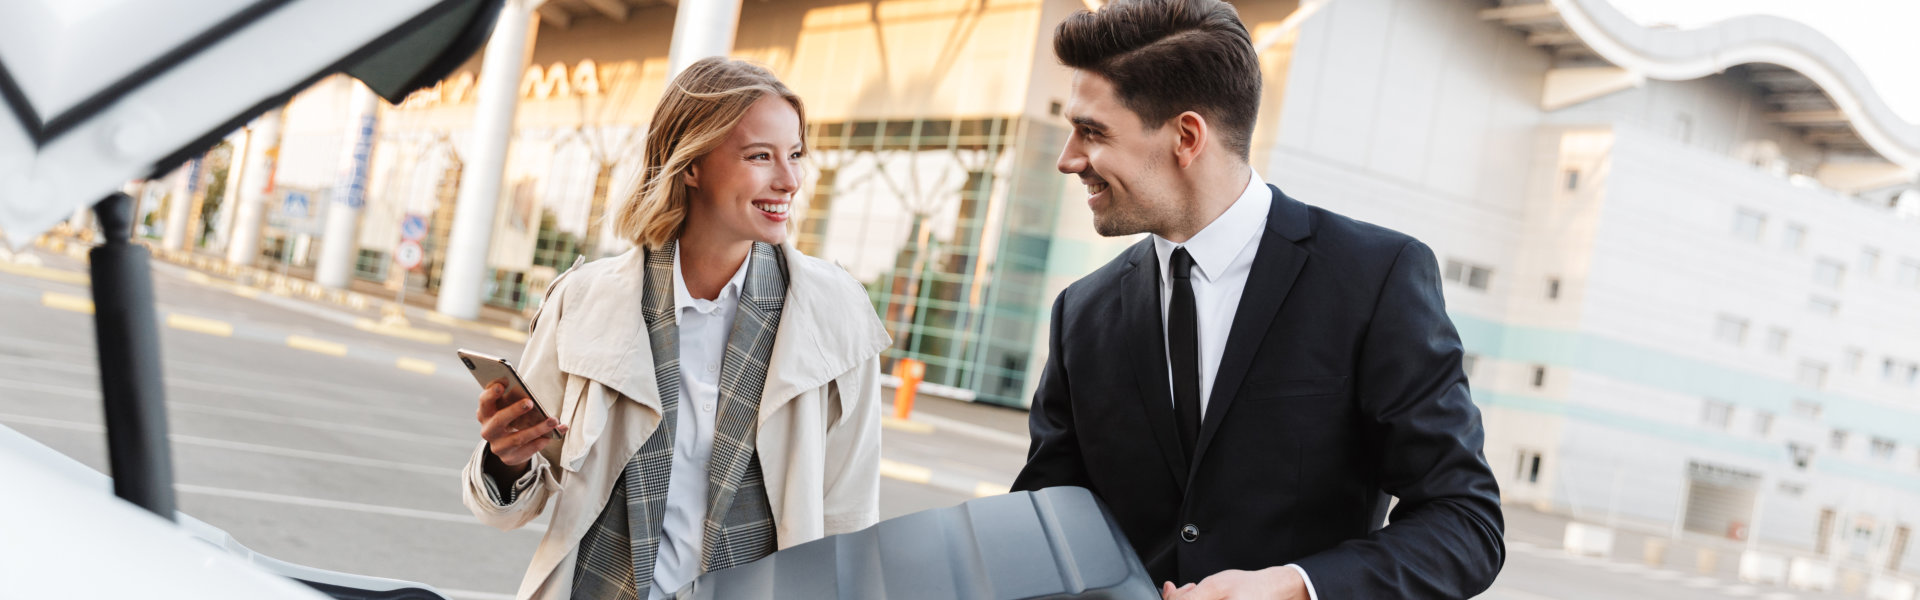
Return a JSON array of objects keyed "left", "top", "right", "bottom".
[{"left": 463, "top": 246, "right": 891, "bottom": 600}]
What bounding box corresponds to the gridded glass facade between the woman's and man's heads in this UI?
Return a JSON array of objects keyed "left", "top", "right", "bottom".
[{"left": 795, "top": 117, "right": 1064, "bottom": 406}]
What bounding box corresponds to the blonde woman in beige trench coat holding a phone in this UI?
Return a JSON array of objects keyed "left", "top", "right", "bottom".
[{"left": 465, "top": 58, "right": 889, "bottom": 600}]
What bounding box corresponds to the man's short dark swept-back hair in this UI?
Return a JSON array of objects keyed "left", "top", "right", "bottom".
[{"left": 1054, "top": 0, "right": 1260, "bottom": 160}]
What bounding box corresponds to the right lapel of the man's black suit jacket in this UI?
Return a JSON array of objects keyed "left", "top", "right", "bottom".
[{"left": 1188, "top": 185, "right": 1313, "bottom": 469}]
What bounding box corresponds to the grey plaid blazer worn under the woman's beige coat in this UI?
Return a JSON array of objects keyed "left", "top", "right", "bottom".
[{"left": 572, "top": 242, "right": 787, "bottom": 600}]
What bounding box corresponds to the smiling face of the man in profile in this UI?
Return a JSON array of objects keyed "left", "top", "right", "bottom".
[{"left": 1056, "top": 71, "right": 1185, "bottom": 237}]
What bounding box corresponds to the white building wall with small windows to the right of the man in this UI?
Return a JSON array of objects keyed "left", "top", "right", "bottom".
[{"left": 1263, "top": 0, "right": 1920, "bottom": 565}]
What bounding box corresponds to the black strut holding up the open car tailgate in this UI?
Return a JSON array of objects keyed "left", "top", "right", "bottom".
[{"left": 88, "top": 192, "right": 175, "bottom": 521}]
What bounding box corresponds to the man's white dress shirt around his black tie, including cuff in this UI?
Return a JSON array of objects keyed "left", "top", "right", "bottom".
[{"left": 1154, "top": 169, "right": 1319, "bottom": 600}]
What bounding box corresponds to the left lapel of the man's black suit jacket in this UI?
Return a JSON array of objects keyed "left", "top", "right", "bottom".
[{"left": 1119, "top": 238, "right": 1188, "bottom": 488}]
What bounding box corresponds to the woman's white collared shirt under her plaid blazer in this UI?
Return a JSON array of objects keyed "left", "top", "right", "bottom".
[{"left": 647, "top": 252, "right": 753, "bottom": 600}]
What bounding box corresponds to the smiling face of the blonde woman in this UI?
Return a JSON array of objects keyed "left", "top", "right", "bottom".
[{"left": 685, "top": 96, "right": 804, "bottom": 244}]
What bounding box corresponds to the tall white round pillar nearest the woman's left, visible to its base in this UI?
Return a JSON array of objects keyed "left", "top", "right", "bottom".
[{"left": 436, "top": 0, "right": 529, "bottom": 319}]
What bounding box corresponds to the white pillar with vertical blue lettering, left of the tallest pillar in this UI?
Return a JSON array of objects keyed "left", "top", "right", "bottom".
[{"left": 313, "top": 79, "right": 380, "bottom": 290}]
